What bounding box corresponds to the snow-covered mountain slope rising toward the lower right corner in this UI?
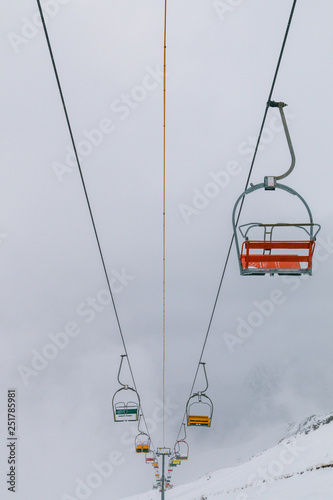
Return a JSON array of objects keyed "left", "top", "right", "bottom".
[{"left": 123, "top": 414, "right": 333, "bottom": 500}]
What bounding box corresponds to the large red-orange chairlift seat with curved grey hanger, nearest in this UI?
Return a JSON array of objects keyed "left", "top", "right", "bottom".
[{"left": 232, "top": 101, "right": 320, "bottom": 276}]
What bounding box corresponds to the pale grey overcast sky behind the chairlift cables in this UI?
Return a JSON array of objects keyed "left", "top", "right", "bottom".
[{"left": 0, "top": 0, "right": 333, "bottom": 500}]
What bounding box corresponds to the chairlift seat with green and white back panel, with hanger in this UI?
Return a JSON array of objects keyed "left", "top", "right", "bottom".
[{"left": 112, "top": 354, "right": 140, "bottom": 422}]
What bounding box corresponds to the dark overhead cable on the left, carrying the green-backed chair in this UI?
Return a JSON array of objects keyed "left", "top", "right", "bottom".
[{"left": 36, "top": 0, "right": 154, "bottom": 452}]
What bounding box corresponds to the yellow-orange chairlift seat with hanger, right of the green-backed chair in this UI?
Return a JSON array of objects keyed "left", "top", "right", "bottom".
[{"left": 186, "top": 362, "right": 214, "bottom": 427}]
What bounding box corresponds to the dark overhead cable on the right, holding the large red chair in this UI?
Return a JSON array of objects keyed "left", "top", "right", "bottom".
[{"left": 176, "top": 0, "right": 297, "bottom": 441}]
